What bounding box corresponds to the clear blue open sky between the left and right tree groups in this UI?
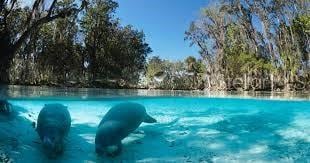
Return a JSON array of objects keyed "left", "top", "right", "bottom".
[{"left": 116, "top": 0, "right": 208, "bottom": 61}]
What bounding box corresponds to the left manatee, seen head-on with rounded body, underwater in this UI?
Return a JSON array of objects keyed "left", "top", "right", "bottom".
[{"left": 36, "top": 104, "right": 71, "bottom": 158}]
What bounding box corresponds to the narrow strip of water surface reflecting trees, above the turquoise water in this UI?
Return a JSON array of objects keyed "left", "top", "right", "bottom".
[{"left": 0, "top": 84, "right": 310, "bottom": 100}]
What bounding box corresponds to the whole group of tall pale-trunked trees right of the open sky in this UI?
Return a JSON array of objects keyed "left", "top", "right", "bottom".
[{"left": 186, "top": 0, "right": 309, "bottom": 90}]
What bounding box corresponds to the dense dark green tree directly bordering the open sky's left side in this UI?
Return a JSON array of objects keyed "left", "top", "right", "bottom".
[{"left": 81, "top": 0, "right": 152, "bottom": 84}]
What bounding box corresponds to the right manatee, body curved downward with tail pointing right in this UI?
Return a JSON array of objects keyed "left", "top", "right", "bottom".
[{"left": 95, "top": 102, "right": 156, "bottom": 156}]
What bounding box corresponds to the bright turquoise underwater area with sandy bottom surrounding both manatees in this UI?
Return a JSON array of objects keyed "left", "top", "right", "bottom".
[{"left": 0, "top": 98, "right": 310, "bottom": 163}]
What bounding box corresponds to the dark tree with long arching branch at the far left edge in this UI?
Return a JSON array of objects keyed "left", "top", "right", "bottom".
[{"left": 0, "top": 0, "right": 86, "bottom": 83}]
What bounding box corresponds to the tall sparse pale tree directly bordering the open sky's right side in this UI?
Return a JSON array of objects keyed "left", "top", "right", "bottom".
[{"left": 186, "top": 4, "right": 230, "bottom": 89}]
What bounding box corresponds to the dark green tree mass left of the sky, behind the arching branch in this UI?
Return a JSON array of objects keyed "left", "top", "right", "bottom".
[{"left": 5, "top": 0, "right": 151, "bottom": 87}]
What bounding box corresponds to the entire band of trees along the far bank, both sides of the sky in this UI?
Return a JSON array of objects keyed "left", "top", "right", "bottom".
[{"left": 0, "top": 0, "right": 310, "bottom": 91}]
